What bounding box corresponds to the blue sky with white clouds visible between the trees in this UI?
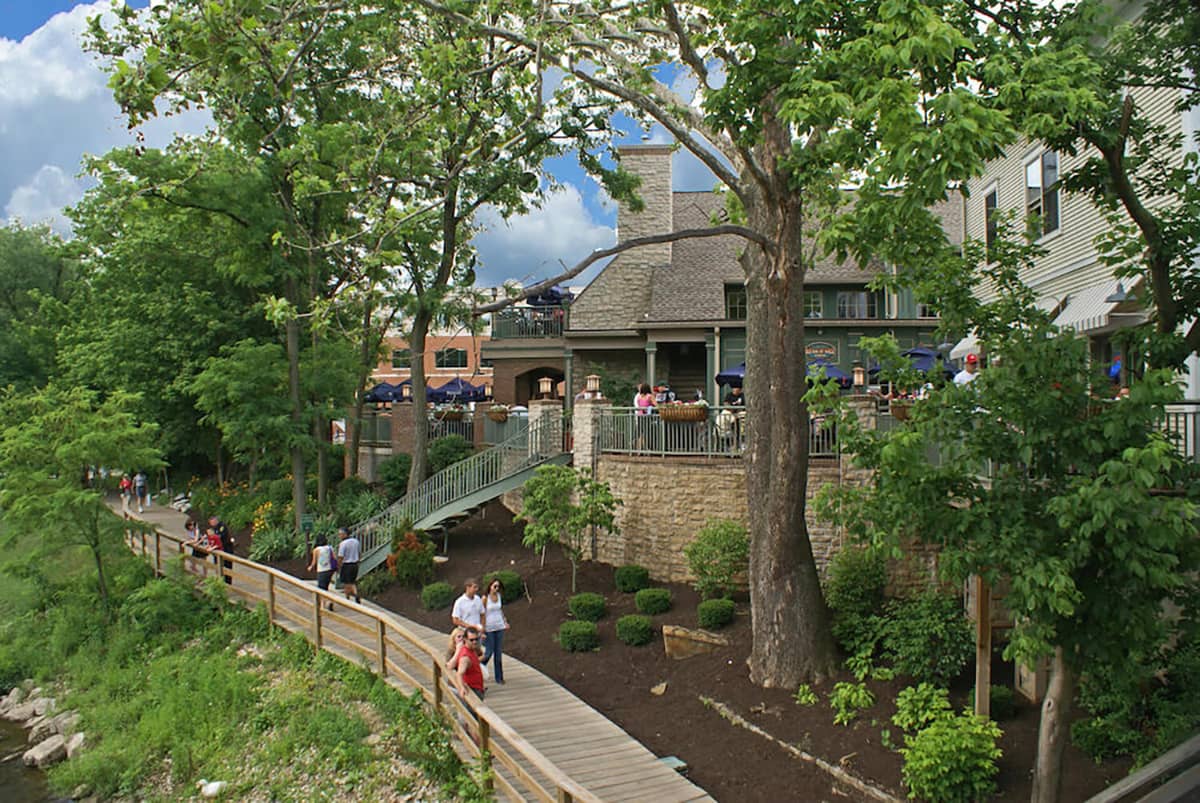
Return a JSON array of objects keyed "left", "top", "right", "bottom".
[{"left": 0, "top": 0, "right": 713, "bottom": 284}]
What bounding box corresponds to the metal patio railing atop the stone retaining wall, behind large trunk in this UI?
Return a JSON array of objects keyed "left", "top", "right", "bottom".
[{"left": 598, "top": 407, "right": 838, "bottom": 457}]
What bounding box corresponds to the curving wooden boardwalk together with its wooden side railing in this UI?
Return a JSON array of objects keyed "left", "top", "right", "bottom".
[{"left": 119, "top": 508, "right": 713, "bottom": 803}]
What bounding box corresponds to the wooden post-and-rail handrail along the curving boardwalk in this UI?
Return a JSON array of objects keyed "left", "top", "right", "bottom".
[{"left": 125, "top": 520, "right": 600, "bottom": 803}]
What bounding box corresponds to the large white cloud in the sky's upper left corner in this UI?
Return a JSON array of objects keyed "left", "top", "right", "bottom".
[{"left": 0, "top": 0, "right": 209, "bottom": 227}]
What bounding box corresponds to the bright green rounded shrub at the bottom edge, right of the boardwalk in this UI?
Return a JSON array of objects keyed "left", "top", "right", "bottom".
[{"left": 900, "top": 713, "right": 1001, "bottom": 803}]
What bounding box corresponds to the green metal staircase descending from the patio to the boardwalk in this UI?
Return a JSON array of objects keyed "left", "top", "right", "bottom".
[{"left": 350, "top": 417, "right": 571, "bottom": 576}]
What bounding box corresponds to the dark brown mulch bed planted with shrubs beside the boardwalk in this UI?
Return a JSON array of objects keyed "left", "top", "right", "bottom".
[{"left": 275, "top": 503, "right": 1129, "bottom": 803}]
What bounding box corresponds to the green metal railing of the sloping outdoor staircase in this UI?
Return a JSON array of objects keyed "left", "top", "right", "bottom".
[{"left": 350, "top": 417, "right": 563, "bottom": 571}]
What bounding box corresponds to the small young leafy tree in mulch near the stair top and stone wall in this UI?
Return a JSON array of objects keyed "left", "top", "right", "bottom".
[{"left": 517, "top": 466, "right": 620, "bottom": 593}]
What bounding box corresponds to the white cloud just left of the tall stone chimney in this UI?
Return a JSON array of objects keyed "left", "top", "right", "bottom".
[{"left": 474, "top": 185, "right": 617, "bottom": 287}]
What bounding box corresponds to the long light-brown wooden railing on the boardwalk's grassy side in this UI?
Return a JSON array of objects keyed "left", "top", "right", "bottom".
[{"left": 126, "top": 529, "right": 600, "bottom": 803}]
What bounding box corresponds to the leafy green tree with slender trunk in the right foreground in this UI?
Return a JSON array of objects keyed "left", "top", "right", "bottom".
[{"left": 823, "top": 245, "right": 1200, "bottom": 801}]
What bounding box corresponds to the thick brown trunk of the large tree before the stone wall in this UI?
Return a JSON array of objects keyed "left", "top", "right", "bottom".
[{"left": 743, "top": 115, "right": 838, "bottom": 688}]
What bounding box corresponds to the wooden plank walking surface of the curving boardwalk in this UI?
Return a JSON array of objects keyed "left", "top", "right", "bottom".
[{"left": 114, "top": 501, "right": 713, "bottom": 803}]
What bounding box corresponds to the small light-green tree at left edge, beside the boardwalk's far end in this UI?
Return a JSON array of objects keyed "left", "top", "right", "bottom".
[{"left": 0, "top": 386, "right": 162, "bottom": 615}]
